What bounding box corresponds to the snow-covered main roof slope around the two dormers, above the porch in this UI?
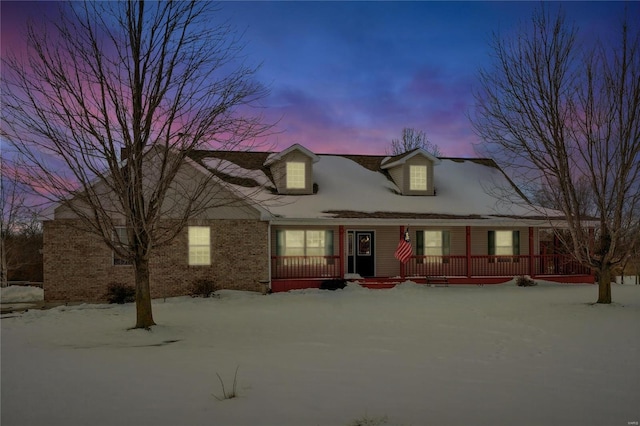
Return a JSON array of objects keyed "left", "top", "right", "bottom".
[{"left": 189, "top": 151, "right": 552, "bottom": 225}]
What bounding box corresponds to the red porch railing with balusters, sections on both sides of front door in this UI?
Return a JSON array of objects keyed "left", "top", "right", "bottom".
[{"left": 271, "top": 254, "right": 590, "bottom": 278}]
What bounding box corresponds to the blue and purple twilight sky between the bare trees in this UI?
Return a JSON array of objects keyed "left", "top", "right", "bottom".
[{"left": 0, "top": 0, "right": 640, "bottom": 156}]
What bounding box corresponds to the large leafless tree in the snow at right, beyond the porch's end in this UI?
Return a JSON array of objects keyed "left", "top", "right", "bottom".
[{"left": 472, "top": 6, "right": 640, "bottom": 303}]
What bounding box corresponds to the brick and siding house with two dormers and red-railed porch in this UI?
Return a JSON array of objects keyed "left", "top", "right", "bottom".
[{"left": 44, "top": 144, "right": 593, "bottom": 301}]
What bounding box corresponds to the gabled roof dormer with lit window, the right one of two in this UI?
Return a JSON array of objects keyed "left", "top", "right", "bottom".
[{"left": 380, "top": 148, "right": 440, "bottom": 195}]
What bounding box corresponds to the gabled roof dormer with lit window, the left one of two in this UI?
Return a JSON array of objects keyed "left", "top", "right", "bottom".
[{"left": 264, "top": 144, "right": 320, "bottom": 195}]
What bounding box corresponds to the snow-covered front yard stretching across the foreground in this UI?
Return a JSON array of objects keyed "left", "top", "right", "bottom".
[{"left": 1, "top": 283, "right": 640, "bottom": 426}]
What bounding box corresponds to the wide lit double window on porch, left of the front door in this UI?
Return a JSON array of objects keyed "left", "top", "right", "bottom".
[{"left": 276, "top": 230, "right": 333, "bottom": 264}]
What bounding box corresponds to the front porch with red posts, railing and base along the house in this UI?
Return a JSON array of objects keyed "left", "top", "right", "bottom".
[{"left": 271, "top": 225, "right": 593, "bottom": 292}]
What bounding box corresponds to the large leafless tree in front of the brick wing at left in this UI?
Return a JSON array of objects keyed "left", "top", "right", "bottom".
[{"left": 2, "top": 0, "right": 269, "bottom": 328}]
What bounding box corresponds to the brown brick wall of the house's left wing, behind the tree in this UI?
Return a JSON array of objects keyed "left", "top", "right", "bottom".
[{"left": 43, "top": 219, "right": 269, "bottom": 302}]
